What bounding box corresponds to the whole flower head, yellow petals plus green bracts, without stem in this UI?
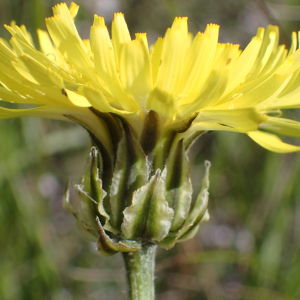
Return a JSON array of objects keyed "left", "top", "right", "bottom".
[{"left": 0, "top": 3, "right": 300, "bottom": 254}]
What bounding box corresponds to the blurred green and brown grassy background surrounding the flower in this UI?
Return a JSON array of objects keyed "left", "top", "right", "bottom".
[{"left": 0, "top": 0, "right": 300, "bottom": 300}]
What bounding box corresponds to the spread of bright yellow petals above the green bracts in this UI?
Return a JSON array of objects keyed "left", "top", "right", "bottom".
[{"left": 0, "top": 3, "right": 300, "bottom": 152}]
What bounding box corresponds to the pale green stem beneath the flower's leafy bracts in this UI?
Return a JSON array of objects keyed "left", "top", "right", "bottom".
[{"left": 123, "top": 244, "right": 157, "bottom": 300}]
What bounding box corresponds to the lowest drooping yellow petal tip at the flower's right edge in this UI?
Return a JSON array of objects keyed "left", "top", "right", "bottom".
[{"left": 248, "top": 131, "right": 300, "bottom": 153}]
